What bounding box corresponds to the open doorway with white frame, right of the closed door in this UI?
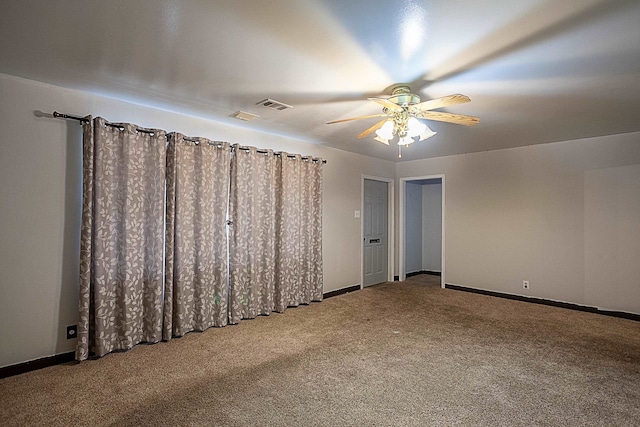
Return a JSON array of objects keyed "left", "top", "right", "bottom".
[{"left": 398, "top": 175, "right": 445, "bottom": 288}]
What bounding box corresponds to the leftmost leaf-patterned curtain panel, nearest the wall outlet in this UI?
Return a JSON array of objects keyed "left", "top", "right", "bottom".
[{"left": 76, "top": 117, "right": 166, "bottom": 360}]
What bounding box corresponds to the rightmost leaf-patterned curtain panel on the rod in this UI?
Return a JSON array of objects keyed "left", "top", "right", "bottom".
[{"left": 275, "top": 152, "right": 323, "bottom": 312}]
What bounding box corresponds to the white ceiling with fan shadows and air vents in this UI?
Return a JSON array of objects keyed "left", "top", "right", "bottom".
[{"left": 0, "top": 0, "right": 640, "bottom": 161}]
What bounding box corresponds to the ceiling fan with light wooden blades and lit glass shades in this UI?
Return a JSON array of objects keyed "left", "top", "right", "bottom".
[{"left": 327, "top": 84, "right": 480, "bottom": 157}]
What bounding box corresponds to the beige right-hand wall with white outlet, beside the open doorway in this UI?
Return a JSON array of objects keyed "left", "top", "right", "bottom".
[{"left": 397, "top": 133, "right": 640, "bottom": 313}]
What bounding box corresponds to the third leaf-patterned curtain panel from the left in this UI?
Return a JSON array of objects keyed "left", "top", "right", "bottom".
[{"left": 229, "top": 145, "right": 280, "bottom": 323}]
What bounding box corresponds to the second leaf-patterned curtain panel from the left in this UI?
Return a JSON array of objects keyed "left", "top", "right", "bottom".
[{"left": 163, "top": 133, "right": 231, "bottom": 340}]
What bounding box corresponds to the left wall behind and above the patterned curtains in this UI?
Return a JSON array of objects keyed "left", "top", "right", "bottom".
[{"left": 0, "top": 75, "right": 395, "bottom": 367}]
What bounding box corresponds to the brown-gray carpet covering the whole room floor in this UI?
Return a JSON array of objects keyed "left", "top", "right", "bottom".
[{"left": 0, "top": 275, "right": 640, "bottom": 426}]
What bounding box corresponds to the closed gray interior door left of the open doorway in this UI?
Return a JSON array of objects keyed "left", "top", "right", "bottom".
[{"left": 362, "top": 179, "right": 389, "bottom": 286}]
